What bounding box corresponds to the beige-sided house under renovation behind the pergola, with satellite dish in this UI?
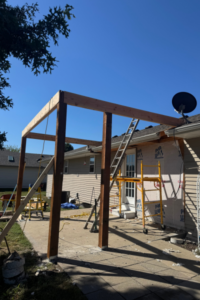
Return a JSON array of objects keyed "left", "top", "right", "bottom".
[{"left": 43, "top": 114, "right": 200, "bottom": 238}]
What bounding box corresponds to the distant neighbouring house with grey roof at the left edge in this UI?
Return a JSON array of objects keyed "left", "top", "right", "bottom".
[{"left": 0, "top": 150, "right": 52, "bottom": 189}]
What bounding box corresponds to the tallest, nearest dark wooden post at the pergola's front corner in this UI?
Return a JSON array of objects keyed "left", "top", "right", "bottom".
[{"left": 47, "top": 91, "right": 67, "bottom": 260}]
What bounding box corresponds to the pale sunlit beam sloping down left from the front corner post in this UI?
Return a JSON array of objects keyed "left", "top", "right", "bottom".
[{"left": 22, "top": 92, "right": 59, "bottom": 136}]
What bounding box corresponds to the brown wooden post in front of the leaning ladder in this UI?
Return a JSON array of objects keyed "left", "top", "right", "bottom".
[{"left": 99, "top": 113, "right": 112, "bottom": 249}]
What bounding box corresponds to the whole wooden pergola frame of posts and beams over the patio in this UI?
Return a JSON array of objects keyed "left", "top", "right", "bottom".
[{"left": 16, "top": 91, "right": 183, "bottom": 259}]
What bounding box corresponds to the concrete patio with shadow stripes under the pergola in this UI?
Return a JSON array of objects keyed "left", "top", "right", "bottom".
[{"left": 20, "top": 209, "right": 200, "bottom": 300}]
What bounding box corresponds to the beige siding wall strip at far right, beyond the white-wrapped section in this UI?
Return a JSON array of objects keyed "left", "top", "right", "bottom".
[{"left": 184, "top": 138, "right": 200, "bottom": 239}]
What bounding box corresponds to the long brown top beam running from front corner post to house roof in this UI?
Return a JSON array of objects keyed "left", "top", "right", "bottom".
[{"left": 64, "top": 92, "right": 184, "bottom": 126}]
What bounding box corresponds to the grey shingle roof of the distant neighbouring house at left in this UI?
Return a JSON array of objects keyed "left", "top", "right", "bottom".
[{"left": 0, "top": 150, "right": 52, "bottom": 167}]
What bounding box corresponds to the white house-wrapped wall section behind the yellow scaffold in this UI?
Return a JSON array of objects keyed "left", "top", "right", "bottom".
[{"left": 137, "top": 142, "right": 184, "bottom": 229}]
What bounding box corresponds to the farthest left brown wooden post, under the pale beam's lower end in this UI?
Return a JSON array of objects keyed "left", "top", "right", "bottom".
[{"left": 15, "top": 137, "right": 26, "bottom": 211}]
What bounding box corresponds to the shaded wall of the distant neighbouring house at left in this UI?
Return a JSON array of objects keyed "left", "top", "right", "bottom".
[{"left": 0, "top": 166, "right": 46, "bottom": 189}]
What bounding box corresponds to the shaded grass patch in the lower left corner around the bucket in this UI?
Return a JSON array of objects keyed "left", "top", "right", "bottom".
[{"left": 0, "top": 223, "right": 87, "bottom": 300}]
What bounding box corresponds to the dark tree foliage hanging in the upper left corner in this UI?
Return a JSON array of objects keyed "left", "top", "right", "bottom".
[{"left": 0, "top": 0, "right": 74, "bottom": 148}]
